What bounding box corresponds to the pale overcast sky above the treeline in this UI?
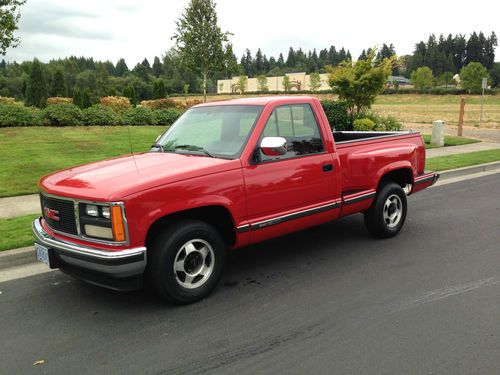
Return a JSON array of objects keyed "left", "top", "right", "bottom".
[{"left": 2, "top": 0, "right": 500, "bottom": 67}]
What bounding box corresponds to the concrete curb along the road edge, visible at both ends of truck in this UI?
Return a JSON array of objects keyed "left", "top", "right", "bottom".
[{"left": 0, "top": 161, "right": 500, "bottom": 270}]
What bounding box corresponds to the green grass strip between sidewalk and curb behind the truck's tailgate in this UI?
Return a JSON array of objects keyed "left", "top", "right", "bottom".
[{"left": 425, "top": 150, "right": 500, "bottom": 171}]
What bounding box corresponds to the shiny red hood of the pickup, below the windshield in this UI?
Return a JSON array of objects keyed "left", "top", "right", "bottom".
[{"left": 39, "top": 152, "right": 241, "bottom": 201}]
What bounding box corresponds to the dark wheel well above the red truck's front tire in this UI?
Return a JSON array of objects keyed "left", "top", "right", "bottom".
[{"left": 146, "top": 206, "right": 236, "bottom": 248}]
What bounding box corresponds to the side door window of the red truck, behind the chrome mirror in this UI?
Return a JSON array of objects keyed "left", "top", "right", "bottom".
[{"left": 259, "top": 104, "right": 324, "bottom": 161}]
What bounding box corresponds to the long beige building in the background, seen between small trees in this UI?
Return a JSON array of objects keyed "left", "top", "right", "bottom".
[{"left": 217, "top": 73, "right": 330, "bottom": 94}]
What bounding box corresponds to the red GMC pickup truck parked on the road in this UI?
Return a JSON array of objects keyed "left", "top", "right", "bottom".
[{"left": 33, "top": 96, "right": 438, "bottom": 303}]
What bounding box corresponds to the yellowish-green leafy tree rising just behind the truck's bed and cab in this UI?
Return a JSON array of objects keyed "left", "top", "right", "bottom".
[{"left": 326, "top": 51, "right": 395, "bottom": 112}]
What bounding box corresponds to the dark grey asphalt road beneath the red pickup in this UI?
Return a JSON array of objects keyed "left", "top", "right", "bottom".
[{"left": 0, "top": 174, "right": 500, "bottom": 374}]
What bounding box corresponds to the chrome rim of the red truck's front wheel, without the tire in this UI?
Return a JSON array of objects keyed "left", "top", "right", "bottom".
[{"left": 174, "top": 239, "right": 215, "bottom": 289}]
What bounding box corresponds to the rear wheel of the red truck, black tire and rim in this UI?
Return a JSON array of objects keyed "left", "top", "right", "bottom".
[{"left": 364, "top": 182, "right": 408, "bottom": 238}]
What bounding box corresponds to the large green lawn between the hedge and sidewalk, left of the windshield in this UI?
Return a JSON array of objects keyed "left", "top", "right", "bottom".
[{"left": 0, "top": 126, "right": 166, "bottom": 197}]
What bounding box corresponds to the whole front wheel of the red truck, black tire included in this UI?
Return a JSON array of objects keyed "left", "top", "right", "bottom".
[{"left": 147, "top": 220, "right": 226, "bottom": 304}]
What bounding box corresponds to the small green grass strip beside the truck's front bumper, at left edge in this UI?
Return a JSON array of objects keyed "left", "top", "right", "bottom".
[{"left": 0, "top": 214, "right": 40, "bottom": 251}]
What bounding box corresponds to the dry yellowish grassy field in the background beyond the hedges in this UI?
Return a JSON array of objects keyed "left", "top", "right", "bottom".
[{"left": 173, "top": 94, "right": 500, "bottom": 128}]
